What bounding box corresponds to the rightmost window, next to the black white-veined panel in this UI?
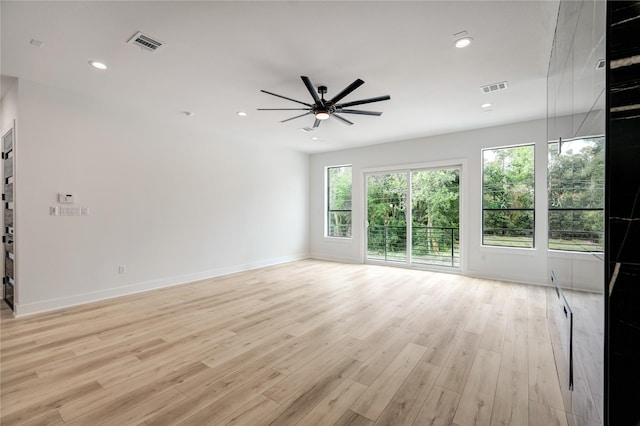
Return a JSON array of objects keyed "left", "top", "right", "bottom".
[{"left": 547, "top": 136, "right": 604, "bottom": 252}]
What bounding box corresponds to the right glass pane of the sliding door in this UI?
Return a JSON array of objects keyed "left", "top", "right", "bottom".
[{"left": 411, "top": 169, "right": 460, "bottom": 267}]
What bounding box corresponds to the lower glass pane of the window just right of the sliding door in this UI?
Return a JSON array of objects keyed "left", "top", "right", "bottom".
[{"left": 482, "top": 210, "right": 534, "bottom": 248}]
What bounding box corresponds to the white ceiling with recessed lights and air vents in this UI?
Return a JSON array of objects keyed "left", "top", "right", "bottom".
[{"left": 1, "top": 0, "right": 558, "bottom": 153}]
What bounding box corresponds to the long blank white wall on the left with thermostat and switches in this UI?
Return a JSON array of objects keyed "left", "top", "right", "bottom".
[{"left": 10, "top": 80, "right": 308, "bottom": 314}]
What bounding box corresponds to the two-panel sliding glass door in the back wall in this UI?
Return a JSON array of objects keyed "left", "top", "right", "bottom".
[{"left": 366, "top": 167, "right": 460, "bottom": 268}]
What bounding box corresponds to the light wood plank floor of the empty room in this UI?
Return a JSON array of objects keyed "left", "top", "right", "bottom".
[{"left": 0, "top": 260, "right": 566, "bottom": 426}]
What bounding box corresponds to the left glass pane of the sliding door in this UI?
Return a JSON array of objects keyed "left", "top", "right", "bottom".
[{"left": 367, "top": 173, "right": 407, "bottom": 262}]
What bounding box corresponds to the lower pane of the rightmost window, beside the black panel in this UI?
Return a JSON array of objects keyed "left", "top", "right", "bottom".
[{"left": 549, "top": 210, "right": 604, "bottom": 251}]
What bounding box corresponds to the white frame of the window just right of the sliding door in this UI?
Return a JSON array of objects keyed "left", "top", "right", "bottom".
[{"left": 480, "top": 142, "right": 537, "bottom": 250}]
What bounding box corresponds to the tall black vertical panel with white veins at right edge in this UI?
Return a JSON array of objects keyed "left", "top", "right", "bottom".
[{"left": 605, "top": 1, "right": 640, "bottom": 426}]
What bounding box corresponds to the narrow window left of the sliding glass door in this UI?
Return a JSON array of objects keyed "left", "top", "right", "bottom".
[{"left": 327, "top": 166, "right": 351, "bottom": 238}]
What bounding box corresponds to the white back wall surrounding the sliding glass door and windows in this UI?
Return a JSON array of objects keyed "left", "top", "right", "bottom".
[{"left": 309, "top": 120, "right": 603, "bottom": 290}]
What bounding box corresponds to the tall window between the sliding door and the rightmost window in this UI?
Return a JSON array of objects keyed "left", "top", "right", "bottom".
[{"left": 482, "top": 145, "right": 535, "bottom": 248}]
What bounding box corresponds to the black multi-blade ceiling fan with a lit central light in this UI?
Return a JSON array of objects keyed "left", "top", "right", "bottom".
[{"left": 258, "top": 75, "right": 391, "bottom": 128}]
